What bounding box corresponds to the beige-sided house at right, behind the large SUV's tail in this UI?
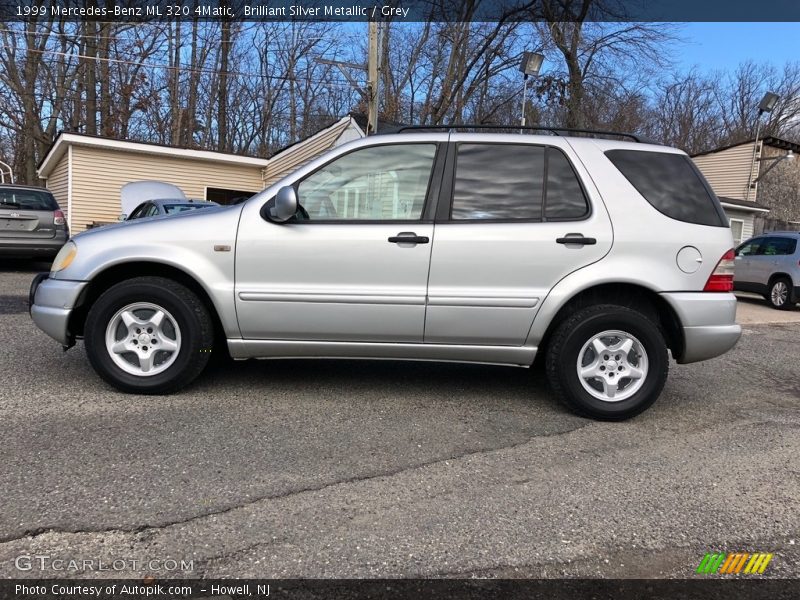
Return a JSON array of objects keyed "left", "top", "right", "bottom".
[{"left": 692, "top": 136, "right": 800, "bottom": 243}]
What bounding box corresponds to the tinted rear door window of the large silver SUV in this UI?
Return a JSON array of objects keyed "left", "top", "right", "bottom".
[{"left": 451, "top": 144, "right": 589, "bottom": 221}]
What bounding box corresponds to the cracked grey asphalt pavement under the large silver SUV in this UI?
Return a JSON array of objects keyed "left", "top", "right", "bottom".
[{"left": 0, "top": 264, "right": 800, "bottom": 577}]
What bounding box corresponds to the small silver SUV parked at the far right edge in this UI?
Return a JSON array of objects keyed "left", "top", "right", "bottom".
[{"left": 733, "top": 231, "right": 800, "bottom": 310}]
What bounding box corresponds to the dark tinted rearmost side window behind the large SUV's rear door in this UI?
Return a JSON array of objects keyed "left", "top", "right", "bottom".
[{"left": 606, "top": 150, "right": 727, "bottom": 227}]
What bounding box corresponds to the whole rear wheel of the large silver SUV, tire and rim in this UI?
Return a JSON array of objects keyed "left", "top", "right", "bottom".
[{"left": 546, "top": 304, "right": 669, "bottom": 420}]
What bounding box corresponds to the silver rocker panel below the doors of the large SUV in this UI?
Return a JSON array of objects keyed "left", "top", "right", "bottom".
[{"left": 228, "top": 339, "right": 536, "bottom": 367}]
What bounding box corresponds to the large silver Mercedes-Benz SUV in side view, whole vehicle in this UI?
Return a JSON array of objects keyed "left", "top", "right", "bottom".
[{"left": 31, "top": 131, "right": 741, "bottom": 419}]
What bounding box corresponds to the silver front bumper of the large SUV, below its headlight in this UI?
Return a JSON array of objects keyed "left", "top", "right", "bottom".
[{"left": 28, "top": 273, "right": 88, "bottom": 347}]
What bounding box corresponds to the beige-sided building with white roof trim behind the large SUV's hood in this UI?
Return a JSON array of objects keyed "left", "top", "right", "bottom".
[{"left": 38, "top": 115, "right": 364, "bottom": 233}]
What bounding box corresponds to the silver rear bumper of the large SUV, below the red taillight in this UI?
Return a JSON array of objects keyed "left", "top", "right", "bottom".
[{"left": 661, "top": 292, "right": 742, "bottom": 364}]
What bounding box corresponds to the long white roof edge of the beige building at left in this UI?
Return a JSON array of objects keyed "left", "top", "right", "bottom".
[{"left": 37, "top": 131, "right": 267, "bottom": 179}]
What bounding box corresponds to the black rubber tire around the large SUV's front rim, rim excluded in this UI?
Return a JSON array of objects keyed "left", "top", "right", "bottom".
[{"left": 84, "top": 277, "right": 214, "bottom": 394}]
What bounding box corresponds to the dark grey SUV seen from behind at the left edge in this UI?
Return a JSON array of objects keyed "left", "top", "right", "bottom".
[{"left": 0, "top": 185, "right": 69, "bottom": 258}]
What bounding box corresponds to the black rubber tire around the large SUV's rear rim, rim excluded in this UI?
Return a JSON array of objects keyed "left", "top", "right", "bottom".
[{"left": 546, "top": 304, "right": 669, "bottom": 421}]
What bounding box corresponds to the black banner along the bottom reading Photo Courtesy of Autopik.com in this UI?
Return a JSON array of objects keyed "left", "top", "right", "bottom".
[{"left": 0, "top": 578, "right": 800, "bottom": 600}]
